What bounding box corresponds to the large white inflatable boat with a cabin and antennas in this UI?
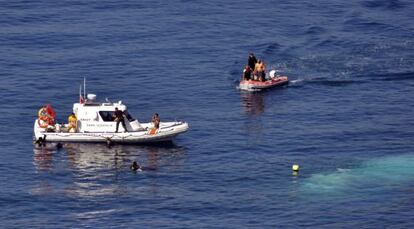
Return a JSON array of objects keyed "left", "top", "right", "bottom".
[{"left": 34, "top": 94, "right": 189, "bottom": 144}]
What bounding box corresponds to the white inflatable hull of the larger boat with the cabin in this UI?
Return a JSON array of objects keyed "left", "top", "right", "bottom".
[{"left": 35, "top": 122, "right": 189, "bottom": 144}]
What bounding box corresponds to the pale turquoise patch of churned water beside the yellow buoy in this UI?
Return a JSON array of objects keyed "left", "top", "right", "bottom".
[{"left": 303, "top": 154, "right": 414, "bottom": 194}]
